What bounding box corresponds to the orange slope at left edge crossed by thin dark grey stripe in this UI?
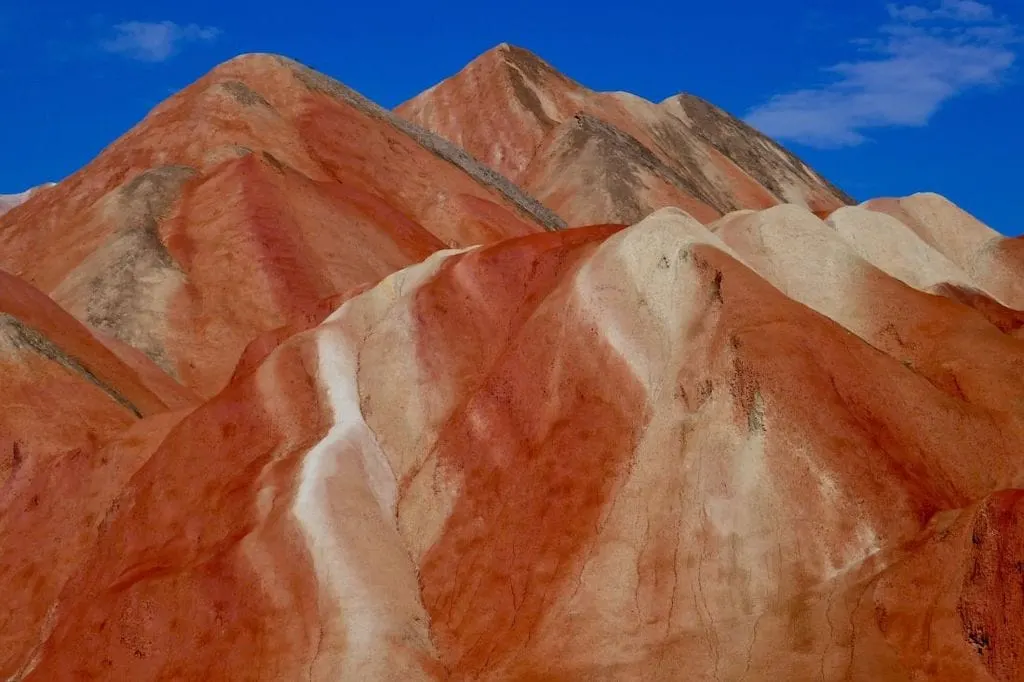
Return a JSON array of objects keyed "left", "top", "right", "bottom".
[{"left": 0, "top": 271, "right": 199, "bottom": 678}]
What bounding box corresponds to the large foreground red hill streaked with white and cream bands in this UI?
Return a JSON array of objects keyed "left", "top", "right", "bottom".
[{"left": 0, "top": 196, "right": 1024, "bottom": 682}]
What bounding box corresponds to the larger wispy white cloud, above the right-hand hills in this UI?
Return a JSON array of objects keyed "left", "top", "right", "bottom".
[{"left": 746, "top": 0, "right": 1019, "bottom": 148}]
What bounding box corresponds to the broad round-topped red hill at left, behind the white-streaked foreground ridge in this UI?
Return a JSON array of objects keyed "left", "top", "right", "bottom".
[{"left": 0, "top": 55, "right": 563, "bottom": 396}]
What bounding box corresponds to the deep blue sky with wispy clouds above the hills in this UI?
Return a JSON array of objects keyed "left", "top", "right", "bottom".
[{"left": 0, "top": 0, "right": 1024, "bottom": 235}]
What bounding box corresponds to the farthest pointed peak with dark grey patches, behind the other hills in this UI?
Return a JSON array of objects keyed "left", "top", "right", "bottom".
[{"left": 396, "top": 44, "right": 852, "bottom": 224}]
